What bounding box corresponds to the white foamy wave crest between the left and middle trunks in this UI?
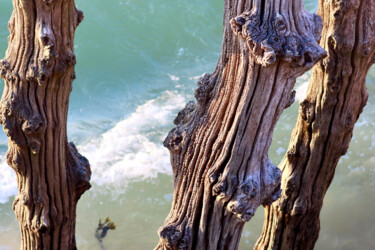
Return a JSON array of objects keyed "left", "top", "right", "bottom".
[{"left": 78, "top": 91, "right": 186, "bottom": 185}]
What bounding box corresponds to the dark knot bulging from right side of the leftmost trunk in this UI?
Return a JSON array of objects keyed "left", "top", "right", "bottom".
[{"left": 68, "top": 142, "right": 91, "bottom": 200}]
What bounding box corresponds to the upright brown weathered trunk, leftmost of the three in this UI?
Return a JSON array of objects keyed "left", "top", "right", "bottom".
[{"left": 0, "top": 0, "right": 91, "bottom": 249}]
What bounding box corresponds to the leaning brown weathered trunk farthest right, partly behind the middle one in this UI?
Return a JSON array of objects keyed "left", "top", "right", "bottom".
[{"left": 255, "top": 0, "right": 375, "bottom": 249}]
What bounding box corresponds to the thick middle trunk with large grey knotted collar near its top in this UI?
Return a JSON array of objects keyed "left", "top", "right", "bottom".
[{"left": 157, "top": 0, "right": 325, "bottom": 249}]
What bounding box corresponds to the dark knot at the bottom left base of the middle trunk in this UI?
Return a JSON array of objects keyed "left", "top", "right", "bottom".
[{"left": 159, "top": 225, "right": 190, "bottom": 249}]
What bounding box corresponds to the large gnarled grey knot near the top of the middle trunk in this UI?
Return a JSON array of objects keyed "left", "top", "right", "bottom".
[{"left": 230, "top": 10, "right": 326, "bottom": 67}]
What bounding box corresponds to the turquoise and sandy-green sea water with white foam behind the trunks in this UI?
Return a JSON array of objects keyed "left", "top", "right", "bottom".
[{"left": 0, "top": 0, "right": 375, "bottom": 249}]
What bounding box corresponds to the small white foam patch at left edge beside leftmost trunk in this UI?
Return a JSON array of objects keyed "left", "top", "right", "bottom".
[{"left": 0, "top": 156, "right": 18, "bottom": 203}]
